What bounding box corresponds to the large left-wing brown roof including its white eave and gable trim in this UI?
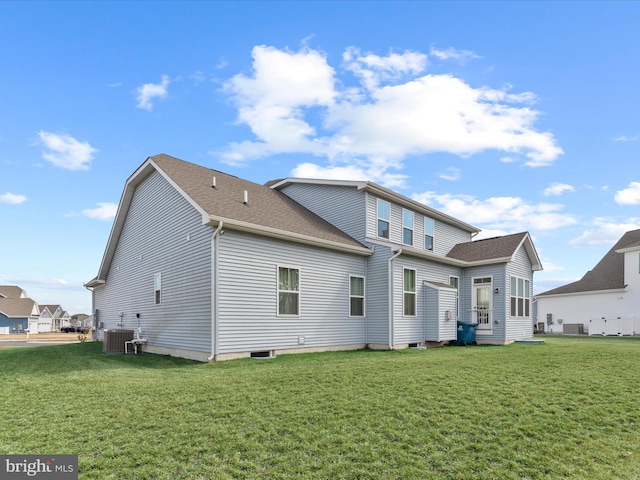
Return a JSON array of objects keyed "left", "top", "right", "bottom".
[{"left": 87, "top": 154, "right": 373, "bottom": 286}]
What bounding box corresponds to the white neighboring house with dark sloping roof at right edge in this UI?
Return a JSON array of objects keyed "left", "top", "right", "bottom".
[{"left": 535, "top": 230, "right": 640, "bottom": 335}]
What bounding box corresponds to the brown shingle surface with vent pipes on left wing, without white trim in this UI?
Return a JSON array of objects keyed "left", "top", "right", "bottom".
[{"left": 150, "top": 154, "right": 364, "bottom": 248}]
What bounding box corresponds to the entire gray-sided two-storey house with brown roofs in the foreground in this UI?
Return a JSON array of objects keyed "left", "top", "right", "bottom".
[{"left": 86, "top": 155, "right": 542, "bottom": 361}]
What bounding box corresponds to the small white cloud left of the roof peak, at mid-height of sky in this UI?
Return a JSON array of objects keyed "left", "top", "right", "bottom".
[{"left": 38, "top": 131, "right": 99, "bottom": 170}]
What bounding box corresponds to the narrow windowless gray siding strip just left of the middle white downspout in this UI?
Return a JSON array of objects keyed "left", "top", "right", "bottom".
[{"left": 366, "top": 244, "right": 393, "bottom": 345}]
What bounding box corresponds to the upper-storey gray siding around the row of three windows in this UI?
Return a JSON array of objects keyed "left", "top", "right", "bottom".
[{"left": 367, "top": 194, "right": 471, "bottom": 256}]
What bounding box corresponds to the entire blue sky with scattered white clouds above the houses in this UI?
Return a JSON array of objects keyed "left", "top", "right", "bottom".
[{"left": 0, "top": 1, "right": 640, "bottom": 314}]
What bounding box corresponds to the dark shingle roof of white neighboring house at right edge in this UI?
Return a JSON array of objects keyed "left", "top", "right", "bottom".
[{"left": 536, "top": 229, "right": 640, "bottom": 297}]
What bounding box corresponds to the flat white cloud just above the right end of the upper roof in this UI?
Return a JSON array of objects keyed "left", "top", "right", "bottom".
[{"left": 412, "top": 192, "right": 578, "bottom": 238}]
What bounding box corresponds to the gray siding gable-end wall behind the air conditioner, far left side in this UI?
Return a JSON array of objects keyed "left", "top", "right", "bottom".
[{"left": 95, "top": 172, "right": 213, "bottom": 352}]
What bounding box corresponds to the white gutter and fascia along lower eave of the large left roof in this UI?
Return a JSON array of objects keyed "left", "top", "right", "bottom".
[{"left": 203, "top": 215, "right": 373, "bottom": 256}]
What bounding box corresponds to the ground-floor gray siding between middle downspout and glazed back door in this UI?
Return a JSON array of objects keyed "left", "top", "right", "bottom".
[{"left": 393, "top": 255, "right": 462, "bottom": 344}]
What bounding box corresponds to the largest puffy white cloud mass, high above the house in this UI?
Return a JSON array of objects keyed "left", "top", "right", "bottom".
[{"left": 220, "top": 46, "right": 562, "bottom": 185}]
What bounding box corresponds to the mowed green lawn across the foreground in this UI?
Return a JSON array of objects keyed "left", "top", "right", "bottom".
[{"left": 0, "top": 337, "right": 640, "bottom": 480}]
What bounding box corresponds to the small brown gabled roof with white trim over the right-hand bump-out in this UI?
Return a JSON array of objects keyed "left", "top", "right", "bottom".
[{"left": 447, "top": 232, "right": 542, "bottom": 271}]
